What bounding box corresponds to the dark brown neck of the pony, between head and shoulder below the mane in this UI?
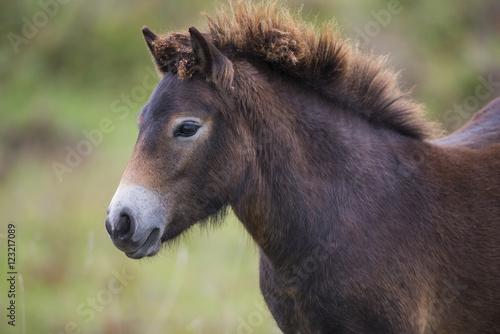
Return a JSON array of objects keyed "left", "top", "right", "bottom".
[{"left": 232, "top": 69, "right": 422, "bottom": 267}]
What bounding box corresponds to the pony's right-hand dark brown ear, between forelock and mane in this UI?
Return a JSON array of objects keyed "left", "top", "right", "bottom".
[{"left": 189, "top": 27, "right": 234, "bottom": 89}]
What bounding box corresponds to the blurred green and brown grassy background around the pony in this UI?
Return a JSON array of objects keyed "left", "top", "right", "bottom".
[{"left": 0, "top": 0, "right": 500, "bottom": 334}]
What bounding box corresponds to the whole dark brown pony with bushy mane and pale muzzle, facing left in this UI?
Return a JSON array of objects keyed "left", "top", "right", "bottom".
[{"left": 105, "top": 3, "right": 500, "bottom": 334}]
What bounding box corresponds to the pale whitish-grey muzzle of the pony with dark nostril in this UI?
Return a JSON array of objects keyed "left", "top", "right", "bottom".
[{"left": 105, "top": 184, "right": 167, "bottom": 259}]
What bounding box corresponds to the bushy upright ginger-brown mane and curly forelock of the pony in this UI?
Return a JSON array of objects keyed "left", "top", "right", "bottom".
[{"left": 152, "top": 1, "right": 435, "bottom": 139}]
